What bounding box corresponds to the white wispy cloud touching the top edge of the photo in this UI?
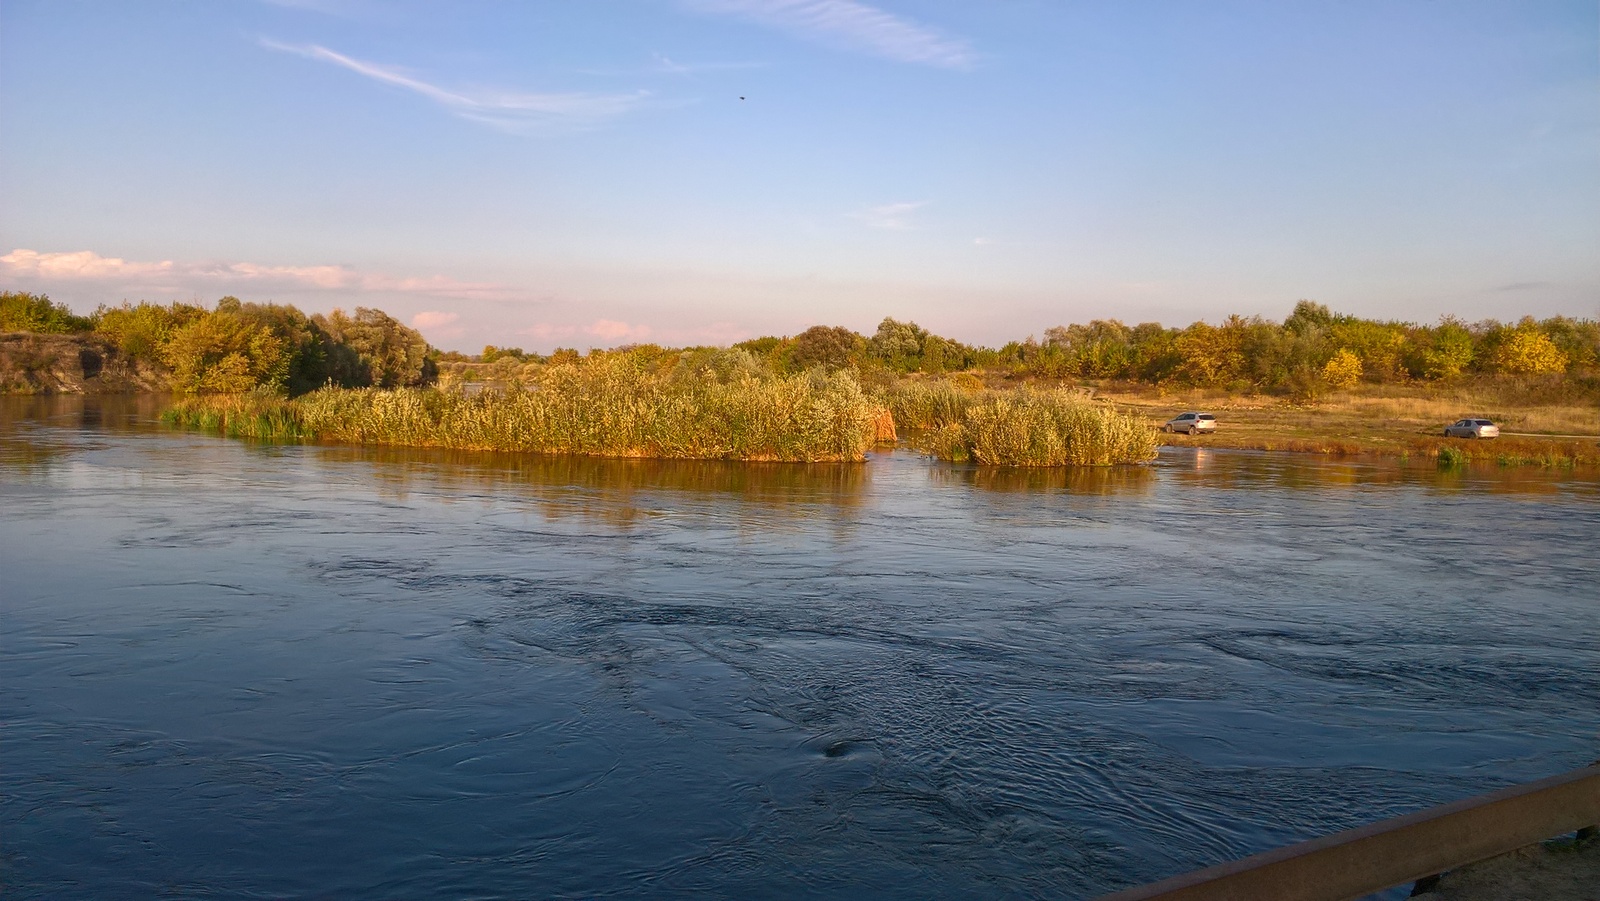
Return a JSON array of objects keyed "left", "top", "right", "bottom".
[{"left": 685, "top": 0, "right": 976, "bottom": 69}]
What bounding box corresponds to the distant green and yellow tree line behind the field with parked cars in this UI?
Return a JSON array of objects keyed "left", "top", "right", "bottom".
[{"left": 460, "top": 301, "right": 1600, "bottom": 395}]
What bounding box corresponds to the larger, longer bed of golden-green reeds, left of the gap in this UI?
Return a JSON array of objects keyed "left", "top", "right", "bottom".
[{"left": 166, "top": 357, "right": 882, "bottom": 461}]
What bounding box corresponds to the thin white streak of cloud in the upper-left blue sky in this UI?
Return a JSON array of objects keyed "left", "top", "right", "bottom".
[{"left": 261, "top": 38, "right": 650, "bottom": 131}]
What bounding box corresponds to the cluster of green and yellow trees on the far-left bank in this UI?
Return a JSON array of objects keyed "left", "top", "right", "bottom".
[{"left": 0, "top": 291, "right": 437, "bottom": 394}]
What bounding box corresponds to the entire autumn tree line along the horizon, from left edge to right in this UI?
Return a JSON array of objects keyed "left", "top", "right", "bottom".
[{"left": 9, "top": 293, "right": 1600, "bottom": 397}]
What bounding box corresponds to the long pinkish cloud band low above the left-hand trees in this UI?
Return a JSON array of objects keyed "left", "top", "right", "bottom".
[{"left": 0, "top": 248, "right": 518, "bottom": 301}]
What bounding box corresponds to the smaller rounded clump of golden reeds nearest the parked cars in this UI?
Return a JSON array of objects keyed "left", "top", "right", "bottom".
[{"left": 931, "top": 387, "right": 1157, "bottom": 466}]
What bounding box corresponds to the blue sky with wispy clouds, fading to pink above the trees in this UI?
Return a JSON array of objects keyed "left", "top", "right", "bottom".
[{"left": 0, "top": 0, "right": 1600, "bottom": 350}]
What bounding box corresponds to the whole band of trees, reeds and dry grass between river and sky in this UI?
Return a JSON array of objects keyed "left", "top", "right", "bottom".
[{"left": 0, "top": 293, "right": 1600, "bottom": 467}]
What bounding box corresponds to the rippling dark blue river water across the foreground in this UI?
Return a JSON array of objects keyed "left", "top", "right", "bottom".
[{"left": 0, "top": 398, "right": 1600, "bottom": 898}]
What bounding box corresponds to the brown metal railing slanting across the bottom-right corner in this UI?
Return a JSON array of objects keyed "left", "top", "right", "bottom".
[{"left": 1099, "top": 762, "right": 1600, "bottom": 901}]
